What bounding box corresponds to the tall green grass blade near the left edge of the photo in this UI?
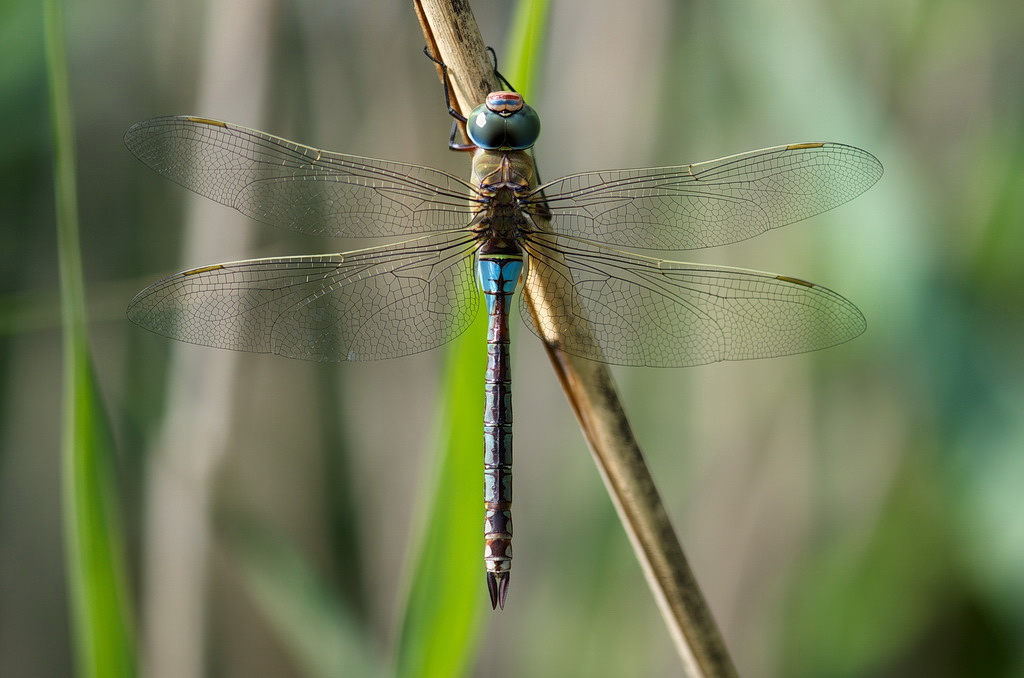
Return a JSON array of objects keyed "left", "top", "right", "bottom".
[{"left": 43, "top": 0, "right": 136, "bottom": 678}]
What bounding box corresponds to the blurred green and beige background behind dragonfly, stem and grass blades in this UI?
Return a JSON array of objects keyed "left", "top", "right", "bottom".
[{"left": 6, "top": 0, "right": 1024, "bottom": 678}]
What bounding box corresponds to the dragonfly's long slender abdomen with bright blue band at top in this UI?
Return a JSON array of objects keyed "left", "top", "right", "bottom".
[{"left": 476, "top": 252, "right": 522, "bottom": 607}]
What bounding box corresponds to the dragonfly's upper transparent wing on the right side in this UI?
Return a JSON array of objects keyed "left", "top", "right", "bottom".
[{"left": 526, "top": 143, "right": 882, "bottom": 250}]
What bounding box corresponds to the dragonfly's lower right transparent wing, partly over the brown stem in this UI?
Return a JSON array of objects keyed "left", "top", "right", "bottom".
[{"left": 522, "top": 235, "right": 865, "bottom": 367}]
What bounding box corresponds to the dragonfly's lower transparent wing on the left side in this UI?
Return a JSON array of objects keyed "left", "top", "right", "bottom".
[{"left": 128, "top": 232, "right": 479, "bottom": 361}]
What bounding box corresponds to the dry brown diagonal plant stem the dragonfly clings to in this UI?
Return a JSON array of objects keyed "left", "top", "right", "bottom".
[{"left": 414, "top": 0, "right": 736, "bottom": 678}]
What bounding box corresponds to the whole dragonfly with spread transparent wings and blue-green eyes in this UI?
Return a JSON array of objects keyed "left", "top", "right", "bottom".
[{"left": 125, "top": 67, "right": 882, "bottom": 608}]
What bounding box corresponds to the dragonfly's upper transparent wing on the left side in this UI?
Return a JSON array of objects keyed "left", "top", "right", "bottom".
[{"left": 125, "top": 116, "right": 472, "bottom": 238}]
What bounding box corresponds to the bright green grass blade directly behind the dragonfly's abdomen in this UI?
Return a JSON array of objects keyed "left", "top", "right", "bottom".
[{"left": 397, "top": 1, "right": 547, "bottom": 678}]
